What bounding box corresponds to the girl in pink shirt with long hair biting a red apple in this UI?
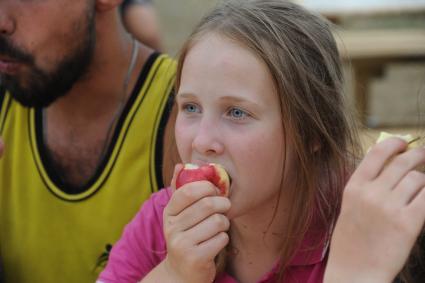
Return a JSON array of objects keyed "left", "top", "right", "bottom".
[{"left": 99, "top": 0, "right": 425, "bottom": 283}]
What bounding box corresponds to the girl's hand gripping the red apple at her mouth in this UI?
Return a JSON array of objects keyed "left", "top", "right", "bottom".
[{"left": 164, "top": 166, "right": 230, "bottom": 283}]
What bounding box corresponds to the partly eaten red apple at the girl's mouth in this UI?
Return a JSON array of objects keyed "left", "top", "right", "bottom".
[{"left": 176, "top": 163, "right": 230, "bottom": 197}]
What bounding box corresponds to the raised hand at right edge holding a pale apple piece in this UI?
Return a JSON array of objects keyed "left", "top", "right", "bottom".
[{"left": 324, "top": 138, "right": 425, "bottom": 283}]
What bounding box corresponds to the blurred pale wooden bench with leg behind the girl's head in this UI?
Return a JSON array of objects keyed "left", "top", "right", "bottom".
[{"left": 335, "top": 29, "right": 425, "bottom": 123}]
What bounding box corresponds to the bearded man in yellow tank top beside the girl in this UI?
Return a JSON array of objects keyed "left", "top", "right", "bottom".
[{"left": 0, "top": 0, "right": 175, "bottom": 283}]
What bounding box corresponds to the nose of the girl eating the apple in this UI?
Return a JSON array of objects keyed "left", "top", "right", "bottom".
[{"left": 192, "top": 120, "right": 224, "bottom": 155}]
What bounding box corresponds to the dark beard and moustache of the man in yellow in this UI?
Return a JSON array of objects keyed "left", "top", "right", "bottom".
[{"left": 0, "top": 8, "right": 96, "bottom": 107}]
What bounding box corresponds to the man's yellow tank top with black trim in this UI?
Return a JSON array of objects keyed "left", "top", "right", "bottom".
[{"left": 0, "top": 54, "right": 175, "bottom": 283}]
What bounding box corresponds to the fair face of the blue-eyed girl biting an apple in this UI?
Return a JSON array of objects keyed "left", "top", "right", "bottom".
[{"left": 175, "top": 34, "right": 288, "bottom": 218}]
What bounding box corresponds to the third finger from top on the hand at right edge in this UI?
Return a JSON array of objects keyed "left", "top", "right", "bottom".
[{"left": 392, "top": 170, "right": 425, "bottom": 206}]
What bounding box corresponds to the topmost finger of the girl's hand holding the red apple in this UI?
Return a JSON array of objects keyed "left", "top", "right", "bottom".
[{"left": 164, "top": 181, "right": 217, "bottom": 216}]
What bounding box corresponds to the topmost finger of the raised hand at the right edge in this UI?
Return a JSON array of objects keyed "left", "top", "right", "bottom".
[{"left": 351, "top": 138, "right": 407, "bottom": 183}]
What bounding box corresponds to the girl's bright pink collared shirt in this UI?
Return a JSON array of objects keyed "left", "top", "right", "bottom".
[{"left": 98, "top": 189, "right": 327, "bottom": 283}]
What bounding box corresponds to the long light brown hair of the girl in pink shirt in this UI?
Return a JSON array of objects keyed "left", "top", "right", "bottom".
[{"left": 176, "top": 0, "right": 360, "bottom": 276}]
